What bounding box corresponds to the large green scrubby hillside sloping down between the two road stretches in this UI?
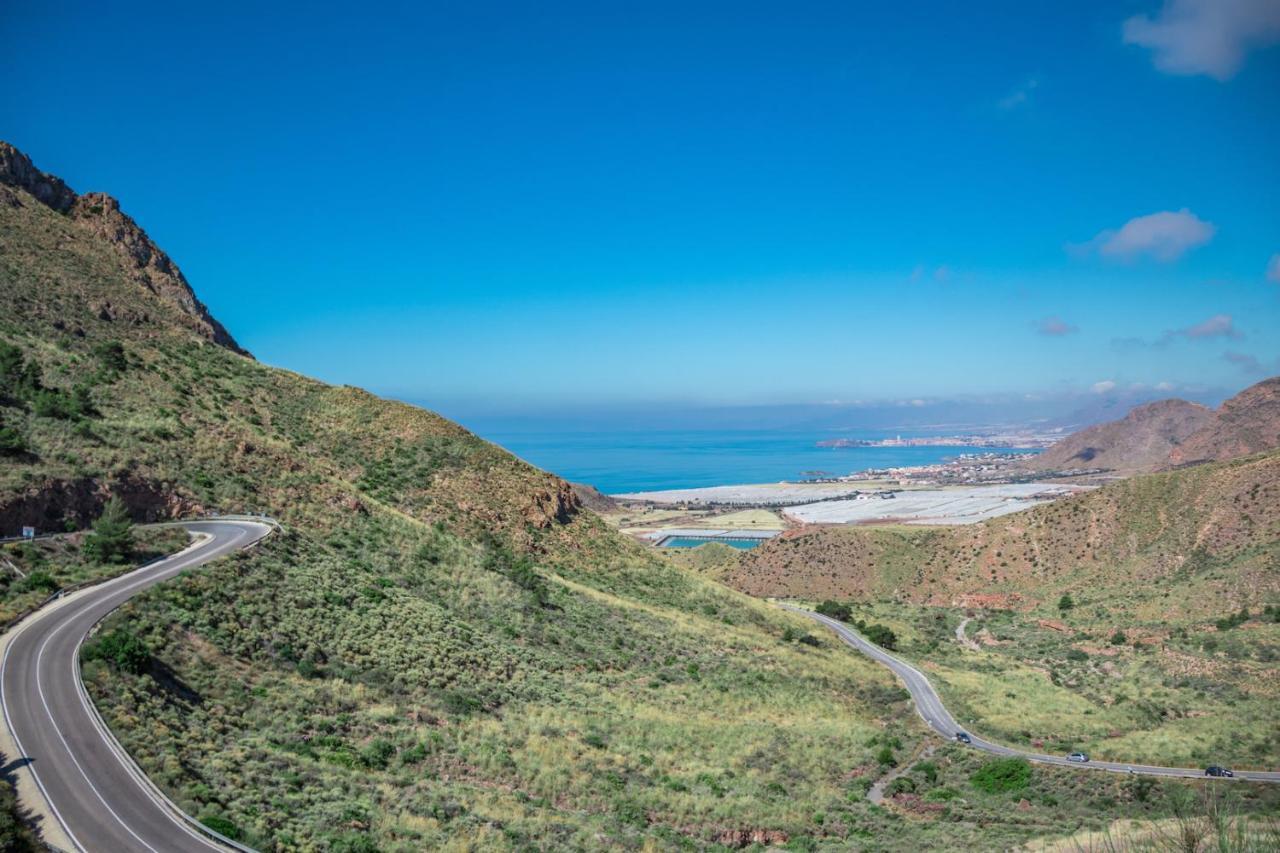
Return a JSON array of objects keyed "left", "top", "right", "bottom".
[{"left": 0, "top": 146, "right": 1270, "bottom": 852}]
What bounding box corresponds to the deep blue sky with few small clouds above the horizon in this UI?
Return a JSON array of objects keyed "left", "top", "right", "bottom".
[{"left": 0, "top": 0, "right": 1280, "bottom": 412}]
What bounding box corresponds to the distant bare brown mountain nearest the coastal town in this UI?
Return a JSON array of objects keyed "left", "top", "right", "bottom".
[{"left": 1021, "top": 400, "right": 1215, "bottom": 473}]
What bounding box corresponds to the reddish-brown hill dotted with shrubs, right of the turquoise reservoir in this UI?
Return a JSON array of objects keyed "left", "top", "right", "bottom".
[{"left": 726, "top": 452, "right": 1280, "bottom": 616}]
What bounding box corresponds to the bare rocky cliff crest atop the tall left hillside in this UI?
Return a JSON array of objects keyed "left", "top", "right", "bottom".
[{"left": 0, "top": 141, "right": 248, "bottom": 355}]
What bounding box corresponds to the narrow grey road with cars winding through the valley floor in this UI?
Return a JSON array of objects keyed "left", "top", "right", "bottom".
[{"left": 782, "top": 605, "right": 1280, "bottom": 783}]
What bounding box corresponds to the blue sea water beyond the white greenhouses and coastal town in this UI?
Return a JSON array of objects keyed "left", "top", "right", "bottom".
[{"left": 481, "top": 429, "right": 1029, "bottom": 494}]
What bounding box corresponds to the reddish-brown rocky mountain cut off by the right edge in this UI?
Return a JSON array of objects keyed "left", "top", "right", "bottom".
[{"left": 1169, "top": 377, "right": 1280, "bottom": 465}]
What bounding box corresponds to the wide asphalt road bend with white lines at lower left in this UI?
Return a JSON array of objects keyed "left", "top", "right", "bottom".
[{"left": 0, "top": 520, "right": 271, "bottom": 853}]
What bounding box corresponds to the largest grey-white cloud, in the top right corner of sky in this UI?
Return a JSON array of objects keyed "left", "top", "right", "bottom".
[{"left": 1124, "top": 0, "right": 1280, "bottom": 81}]
